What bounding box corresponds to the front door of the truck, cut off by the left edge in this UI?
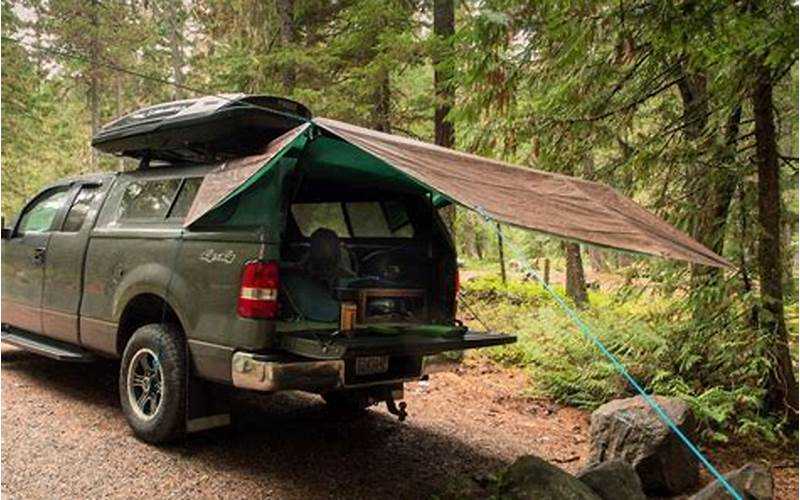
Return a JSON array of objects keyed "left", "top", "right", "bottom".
[{"left": 2, "top": 185, "right": 70, "bottom": 333}]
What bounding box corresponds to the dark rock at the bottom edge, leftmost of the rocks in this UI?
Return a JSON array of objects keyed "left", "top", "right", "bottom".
[{"left": 495, "top": 455, "right": 601, "bottom": 500}]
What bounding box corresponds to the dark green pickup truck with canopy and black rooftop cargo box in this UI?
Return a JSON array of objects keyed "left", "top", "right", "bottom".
[{"left": 2, "top": 98, "right": 514, "bottom": 442}]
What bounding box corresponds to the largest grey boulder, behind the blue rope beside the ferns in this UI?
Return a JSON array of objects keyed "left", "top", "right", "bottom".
[{"left": 588, "top": 396, "right": 699, "bottom": 496}]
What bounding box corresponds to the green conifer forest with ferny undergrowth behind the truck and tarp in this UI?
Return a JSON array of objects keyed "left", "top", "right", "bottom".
[{"left": 2, "top": 0, "right": 799, "bottom": 442}]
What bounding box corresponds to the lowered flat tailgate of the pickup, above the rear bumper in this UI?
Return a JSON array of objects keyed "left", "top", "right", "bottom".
[{"left": 280, "top": 331, "right": 517, "bottom": 359}]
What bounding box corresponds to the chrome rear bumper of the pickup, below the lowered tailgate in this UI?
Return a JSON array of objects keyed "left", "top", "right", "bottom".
[{"left": 231, "top": 352, "right": 422, "bottom": 392}]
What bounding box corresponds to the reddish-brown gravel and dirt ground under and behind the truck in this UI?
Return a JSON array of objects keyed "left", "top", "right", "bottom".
[{"left": 1, "top": 346, "right": 798, "bottom": 499}]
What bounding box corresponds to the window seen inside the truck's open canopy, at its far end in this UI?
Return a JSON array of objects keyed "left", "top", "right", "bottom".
[{"left": 292, "top": 201, "right": 414, "bottom": 238}]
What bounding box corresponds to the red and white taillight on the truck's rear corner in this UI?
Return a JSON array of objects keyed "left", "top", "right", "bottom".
[{"left": 236, "top": 260, "right": 280, "bottom": 319}]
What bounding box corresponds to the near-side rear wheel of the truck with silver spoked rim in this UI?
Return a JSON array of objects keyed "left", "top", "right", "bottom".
[{"left": 119, "top": 324, "right": 187, "bottom": 444}]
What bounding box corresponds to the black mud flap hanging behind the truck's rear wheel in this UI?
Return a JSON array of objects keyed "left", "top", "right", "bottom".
[{"left": 186, "top": 376, "right": 231, "bottom": 433}]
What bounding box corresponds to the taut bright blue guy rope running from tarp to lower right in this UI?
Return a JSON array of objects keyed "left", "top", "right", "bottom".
[{"left": 476, "top": 207, "right": 744, "bottom": 500}]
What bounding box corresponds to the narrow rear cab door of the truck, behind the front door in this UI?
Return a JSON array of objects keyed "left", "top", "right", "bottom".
[{"left": 42, "top": 182, "right": 109, "bottom": 344}]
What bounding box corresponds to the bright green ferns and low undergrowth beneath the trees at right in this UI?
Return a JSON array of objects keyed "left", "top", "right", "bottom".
[{"left": 461, "top": 277, "right": 797, "bottom": 442}]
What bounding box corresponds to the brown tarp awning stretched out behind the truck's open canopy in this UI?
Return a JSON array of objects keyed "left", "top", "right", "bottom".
[{"left": 314, "top": 118, "right": 732, "bottom": 267}]
